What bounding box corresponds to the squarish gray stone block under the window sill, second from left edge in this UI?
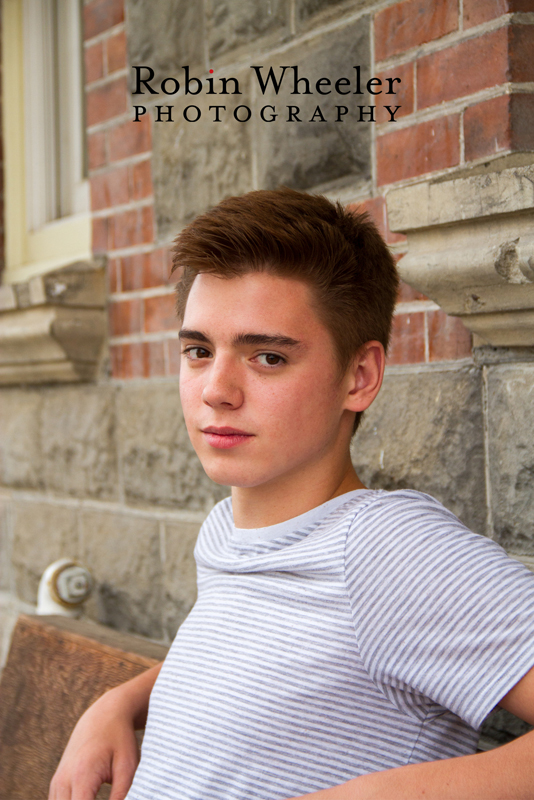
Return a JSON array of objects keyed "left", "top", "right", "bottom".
[{"left": 41, "top": 385, "right": 118, "bottom": 500}]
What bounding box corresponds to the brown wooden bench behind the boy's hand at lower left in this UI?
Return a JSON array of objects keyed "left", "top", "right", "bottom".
[{"left": 0, "top": 615, "right": 167, "bottom": 800}]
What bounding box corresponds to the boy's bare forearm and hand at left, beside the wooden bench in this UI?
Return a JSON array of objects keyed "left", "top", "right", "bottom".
[{"left": 49, "top": 664, "right": 161, "bottom": 800}]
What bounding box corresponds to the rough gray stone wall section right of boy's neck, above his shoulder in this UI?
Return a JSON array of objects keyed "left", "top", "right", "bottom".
[{"left": 352, "top": 356, "right": 534, "bottom": 552}]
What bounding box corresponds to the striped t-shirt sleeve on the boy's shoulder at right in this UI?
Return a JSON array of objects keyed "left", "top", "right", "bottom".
[{"left": 345, "top": 491, "right": 534, "bottom": 728}]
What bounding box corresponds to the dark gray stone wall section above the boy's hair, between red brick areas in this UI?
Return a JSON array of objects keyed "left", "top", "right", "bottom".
[{"left": 127, "top": 0, "right": 374, "bottom": 242}]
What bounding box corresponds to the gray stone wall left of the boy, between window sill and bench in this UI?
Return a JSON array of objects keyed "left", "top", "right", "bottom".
[{"left": 0, "top": 380, "right": 227, "bottom": 641}]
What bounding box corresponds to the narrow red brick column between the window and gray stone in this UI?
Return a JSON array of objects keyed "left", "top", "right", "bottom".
[{"left": 84, "top": 0, "right": 179, "bottom": 378}]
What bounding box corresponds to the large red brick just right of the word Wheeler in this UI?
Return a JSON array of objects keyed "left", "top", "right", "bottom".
[{"left": 417, "top": 28, "right": 509, "bottom": 108}]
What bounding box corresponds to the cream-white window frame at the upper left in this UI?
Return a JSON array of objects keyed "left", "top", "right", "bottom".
[{"left": 2, "top": 0, "right": 92, "bottom": 283}]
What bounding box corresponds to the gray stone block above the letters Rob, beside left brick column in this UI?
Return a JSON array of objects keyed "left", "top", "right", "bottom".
[{"left": 126, "top": 0, "right": 205, "bottom": 82}]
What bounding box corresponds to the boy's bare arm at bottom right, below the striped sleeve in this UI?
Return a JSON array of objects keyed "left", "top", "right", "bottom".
[{"left": 293, "top": 668, "right": 534, "bottom": 800}]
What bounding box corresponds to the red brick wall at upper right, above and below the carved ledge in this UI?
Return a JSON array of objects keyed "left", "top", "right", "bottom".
[{"left": 356, "top": 0, "right": 534, "bottom": 364}]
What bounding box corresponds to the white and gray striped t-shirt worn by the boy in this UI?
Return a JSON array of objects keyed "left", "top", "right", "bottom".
[{"left": 128, "top": 490, "right": 534, "bottom": 800}]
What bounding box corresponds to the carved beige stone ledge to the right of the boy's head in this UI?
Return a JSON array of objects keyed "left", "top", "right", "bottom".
[{"left": 387, "top": 161, "right": 534, "bottom": 347}]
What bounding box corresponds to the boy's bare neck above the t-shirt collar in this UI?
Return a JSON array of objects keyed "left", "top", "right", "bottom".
[{"left": 232, "top": 454, "right": 365, "bottom": 528}]
